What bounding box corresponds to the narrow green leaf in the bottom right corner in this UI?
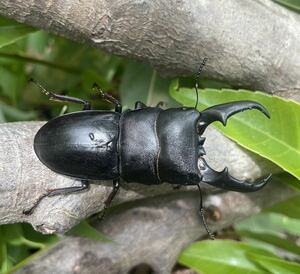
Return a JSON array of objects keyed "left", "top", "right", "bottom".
[{"left": 248, "top": 253, "right": 300, "bottom": 274}]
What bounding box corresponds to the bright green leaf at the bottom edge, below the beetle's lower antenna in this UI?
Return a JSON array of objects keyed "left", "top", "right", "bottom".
[{"left": 178, "top": 240, "right": 275, "bottom": 274}]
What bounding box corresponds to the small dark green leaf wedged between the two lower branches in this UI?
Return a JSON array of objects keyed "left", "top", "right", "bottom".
[{"left": 67, "top": 221, "right": 110, "bottom": 241}]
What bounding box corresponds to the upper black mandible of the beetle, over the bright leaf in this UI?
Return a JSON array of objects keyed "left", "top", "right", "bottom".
[{"left": 199, "top": 101, "right": 270, "bottom": 135}]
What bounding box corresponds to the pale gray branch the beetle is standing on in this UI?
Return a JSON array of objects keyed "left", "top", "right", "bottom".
[{"left": 0, "top": 122, "right": 280, "bottom": 233}]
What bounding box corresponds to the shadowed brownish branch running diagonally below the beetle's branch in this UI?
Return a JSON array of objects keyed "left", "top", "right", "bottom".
[{"left": 16, "top": 183, "right": 294, "bottom": 274}]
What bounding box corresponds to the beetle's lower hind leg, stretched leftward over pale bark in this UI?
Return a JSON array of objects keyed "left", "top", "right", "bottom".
[{"left": 23, "top": 180, "right": 90, "bottom": 215}]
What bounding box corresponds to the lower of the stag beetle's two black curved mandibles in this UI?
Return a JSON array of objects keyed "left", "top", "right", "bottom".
[{"left": 199, "top": 157, "right": 272, "bottom": 192}]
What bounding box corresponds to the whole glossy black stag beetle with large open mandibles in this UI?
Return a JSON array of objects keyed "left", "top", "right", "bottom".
[{"left": 24, "top": 63, "right": 271, "bottom": 239}]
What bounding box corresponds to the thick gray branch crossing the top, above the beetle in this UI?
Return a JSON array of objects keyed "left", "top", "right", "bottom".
[{"left": 0, "top": 0, "right": 300, "bottom": 96}]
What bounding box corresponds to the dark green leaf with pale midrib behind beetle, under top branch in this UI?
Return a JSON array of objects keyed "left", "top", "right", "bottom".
[{"left": 120, "top": 61, "right": 174, "bottom": 108}]
